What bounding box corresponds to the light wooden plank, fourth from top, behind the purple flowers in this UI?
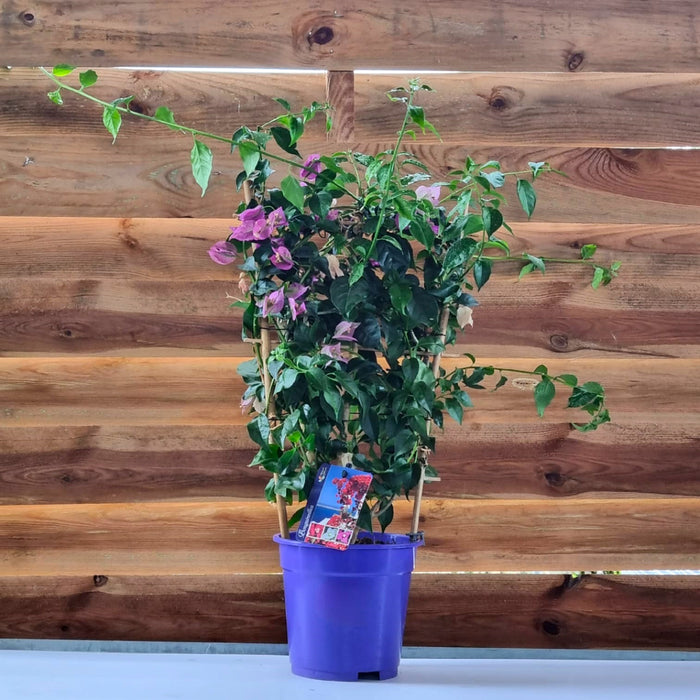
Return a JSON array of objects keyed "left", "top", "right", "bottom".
[{"left": 0, "top": 221, "right": 700, "bottom": 282}]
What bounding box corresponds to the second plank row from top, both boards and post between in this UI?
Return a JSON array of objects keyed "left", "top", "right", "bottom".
[{"left": 5, "top": 68, "right": 700, "bottom": 148}]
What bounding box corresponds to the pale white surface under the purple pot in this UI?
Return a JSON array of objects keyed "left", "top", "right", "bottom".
[{"left": 0, "top": 651, "right": 700, "bottom": 700}]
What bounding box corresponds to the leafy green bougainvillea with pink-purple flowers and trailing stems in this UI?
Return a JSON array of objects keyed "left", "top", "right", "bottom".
[{"left": 45, "top": 66, "right": 619, "bottom": 529}]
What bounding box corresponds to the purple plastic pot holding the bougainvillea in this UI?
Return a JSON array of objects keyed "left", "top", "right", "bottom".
[{"left": 273, "top": 533, "right": 423, "bottom": 681}]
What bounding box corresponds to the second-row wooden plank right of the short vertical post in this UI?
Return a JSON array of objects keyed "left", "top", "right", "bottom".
[{"left": 354, "top": 73, "right": 700, "bottom": 148}]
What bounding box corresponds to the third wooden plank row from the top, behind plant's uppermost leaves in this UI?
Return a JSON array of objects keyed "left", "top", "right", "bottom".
[{"left": 5, "top": 137, "right": 700, "bottom": 224}]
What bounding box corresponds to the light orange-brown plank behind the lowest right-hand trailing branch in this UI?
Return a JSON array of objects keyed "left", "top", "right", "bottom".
[{"left": 0, "top": 356, "right": 700, "bottom": 427}]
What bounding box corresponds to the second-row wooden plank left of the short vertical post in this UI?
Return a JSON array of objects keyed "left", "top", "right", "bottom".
[{"left": 0, "top": 68, "right": 330, "bottom": 142}]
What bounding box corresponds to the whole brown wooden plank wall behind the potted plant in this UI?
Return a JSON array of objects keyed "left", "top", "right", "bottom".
[{"left": 0, "top": 0, "right": 700, "bottom": 649}]
